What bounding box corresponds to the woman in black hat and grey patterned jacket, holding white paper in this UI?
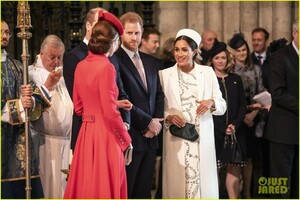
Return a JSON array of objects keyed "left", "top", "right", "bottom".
[{"left": 229, "top": 33, "right": 265, "bottom": 198}]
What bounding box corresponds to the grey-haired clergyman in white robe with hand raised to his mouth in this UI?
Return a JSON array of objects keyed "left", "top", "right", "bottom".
[{"left": 28, "top": 35, "right": 73, "bottom": 198}]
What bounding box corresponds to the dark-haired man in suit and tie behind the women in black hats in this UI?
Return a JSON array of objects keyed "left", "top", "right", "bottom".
[{"left": 251, "top": 27, "right": 270, "bottom": 89}]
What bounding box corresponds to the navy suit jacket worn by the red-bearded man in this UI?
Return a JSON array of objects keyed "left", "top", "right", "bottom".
[{"left": 115, "top": 47, "right": 164, "bottom": 151}]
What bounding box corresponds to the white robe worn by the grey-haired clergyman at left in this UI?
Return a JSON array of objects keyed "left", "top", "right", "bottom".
[{"left": 28, "top": 55, "right": 73, "bottom": 198}]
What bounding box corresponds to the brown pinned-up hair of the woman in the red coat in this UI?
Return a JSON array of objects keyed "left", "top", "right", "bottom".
[{"left": 88, "top": 20, "right": 119, "bottom": 54}]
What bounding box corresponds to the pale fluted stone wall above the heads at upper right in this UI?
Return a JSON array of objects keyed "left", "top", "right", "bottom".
[{"left": 155, "top": 1, "right": 299, "bottom": 50}]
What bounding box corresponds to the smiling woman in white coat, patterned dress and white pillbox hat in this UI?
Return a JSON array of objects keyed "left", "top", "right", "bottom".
[{"left": 160, "top": 29, "right": 226, "bottom": 198}]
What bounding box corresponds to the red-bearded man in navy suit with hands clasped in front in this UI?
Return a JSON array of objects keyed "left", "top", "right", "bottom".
[{"left": 115, "top": 12, "right": 164, "bottom": 199}]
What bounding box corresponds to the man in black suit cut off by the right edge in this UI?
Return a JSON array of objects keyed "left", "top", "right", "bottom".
[{"left": 266, "top": 20, "right": 299, "bottom": 199}]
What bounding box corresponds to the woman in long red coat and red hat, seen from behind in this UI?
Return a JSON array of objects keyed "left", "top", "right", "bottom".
[{"left": 64, "top": 11, "right": 131, "bottom": 199}]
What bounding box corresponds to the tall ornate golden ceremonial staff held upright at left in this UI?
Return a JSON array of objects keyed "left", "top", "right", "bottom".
[{"left": 17, "top": 1, "right": 32, "bottom": 199}]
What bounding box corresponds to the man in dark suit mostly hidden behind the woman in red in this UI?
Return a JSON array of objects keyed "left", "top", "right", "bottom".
[{"left": 63, "top": 8, "right": 132, "bottom": 150}]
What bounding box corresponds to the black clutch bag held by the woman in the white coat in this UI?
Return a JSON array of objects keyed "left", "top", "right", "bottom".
[{"left": 169, "top": 123, "right": 199, "bottom": 142}]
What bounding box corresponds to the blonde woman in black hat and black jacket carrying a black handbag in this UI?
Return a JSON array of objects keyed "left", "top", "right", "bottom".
[{"left": 208, "top": 40, "right": 246, "bottom": 199}]
